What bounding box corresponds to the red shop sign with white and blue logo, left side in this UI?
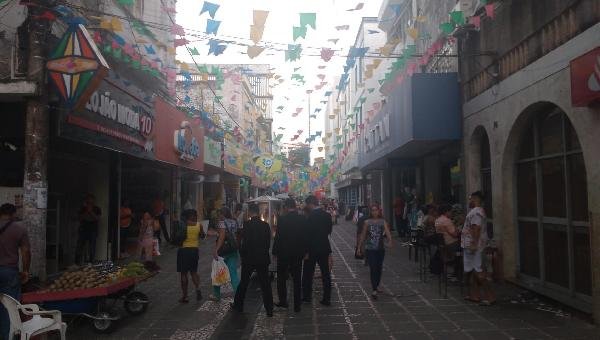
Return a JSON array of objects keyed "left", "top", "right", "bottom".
[{"left": 154, "top": 98, "right": 204, "bottom": 171}]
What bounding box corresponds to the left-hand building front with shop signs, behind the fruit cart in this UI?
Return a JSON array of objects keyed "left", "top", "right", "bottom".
[{"left": 0, "top": 0, "right": 204, "bottom": 279}]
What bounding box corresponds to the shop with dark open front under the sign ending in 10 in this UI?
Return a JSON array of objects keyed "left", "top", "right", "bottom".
[{"left": 47, "top": 71, "right": 157, "bottom": 273}]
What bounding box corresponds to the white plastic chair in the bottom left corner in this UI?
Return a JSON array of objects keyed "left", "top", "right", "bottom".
[{"left": 0, "top": 294, "right": 67, "bottom": 340}]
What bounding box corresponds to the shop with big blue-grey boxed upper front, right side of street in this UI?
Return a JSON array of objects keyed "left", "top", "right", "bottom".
[{"left": 360, "top": 73, "right": 461, "bottom": 223}]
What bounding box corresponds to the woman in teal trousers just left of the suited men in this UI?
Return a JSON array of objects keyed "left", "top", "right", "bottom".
[{"left": 210, "top": 207, "right": 242, "bottom": 301}]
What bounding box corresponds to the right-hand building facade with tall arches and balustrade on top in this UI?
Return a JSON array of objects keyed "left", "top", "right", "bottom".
[{"left": 455, "top": 0, "right": 600, "bottom": 320}]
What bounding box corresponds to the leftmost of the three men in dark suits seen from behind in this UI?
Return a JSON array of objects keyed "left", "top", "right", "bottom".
[{"left": 231, "top": 204, "right": 273, "bottom": 317}]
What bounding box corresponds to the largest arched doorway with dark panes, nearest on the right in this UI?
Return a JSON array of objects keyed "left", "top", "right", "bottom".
[{"left": 516, "top": 103, "right": 592, "bottom": 297}]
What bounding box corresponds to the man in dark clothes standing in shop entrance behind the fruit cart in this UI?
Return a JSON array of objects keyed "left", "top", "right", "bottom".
[{"left": 75, "top": 194, "right": 102, "bottom": 263}]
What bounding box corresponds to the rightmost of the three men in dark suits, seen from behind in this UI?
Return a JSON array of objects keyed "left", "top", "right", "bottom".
[{"left": 302, "top": 195, "right": 333, "bottom": 306}]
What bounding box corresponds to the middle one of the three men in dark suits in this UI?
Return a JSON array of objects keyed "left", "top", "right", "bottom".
[{"left": 273, "top": 198, "right": 307, "bottom": 312}]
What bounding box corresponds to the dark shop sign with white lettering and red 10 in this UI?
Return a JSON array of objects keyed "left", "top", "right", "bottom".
[{"left": 59, "top": 70, "right": 155, "bottom": 159}]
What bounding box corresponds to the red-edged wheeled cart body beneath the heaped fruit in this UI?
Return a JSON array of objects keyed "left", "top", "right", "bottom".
[{"left": 22, "top": 262, "right": 156, "bottom": 333}]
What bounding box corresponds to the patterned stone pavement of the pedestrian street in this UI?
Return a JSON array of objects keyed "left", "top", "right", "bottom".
[{"left": 68, "top": 223, "right": 600, "bottom": 340}]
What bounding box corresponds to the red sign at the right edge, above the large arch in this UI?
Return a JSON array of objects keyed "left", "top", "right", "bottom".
[{"left": 571, "top": 47, "right": 600, "bottom": 107}]
